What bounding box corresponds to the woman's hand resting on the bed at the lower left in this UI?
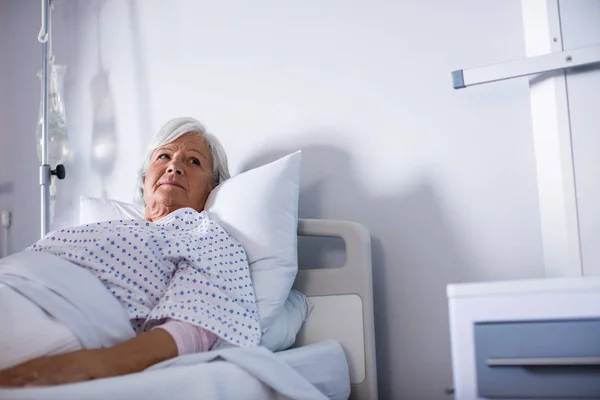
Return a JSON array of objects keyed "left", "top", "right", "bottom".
[{"left": 0, "top": 350, "right": 106, "bottom": 386}]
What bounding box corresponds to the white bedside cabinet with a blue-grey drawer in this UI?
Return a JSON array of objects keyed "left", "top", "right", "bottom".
[{"left": 447, "top": 277, "right": 600, "bottom": 400}]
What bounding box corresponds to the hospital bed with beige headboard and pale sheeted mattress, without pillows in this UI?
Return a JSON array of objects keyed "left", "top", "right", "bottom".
[{"left": 0, "top": 219, "right": 377, "bottom": 400}]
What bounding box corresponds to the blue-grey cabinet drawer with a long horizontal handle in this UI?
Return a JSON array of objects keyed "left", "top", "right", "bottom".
[{"left": 474, "top": 319, "right": 600, "bottom": 399}]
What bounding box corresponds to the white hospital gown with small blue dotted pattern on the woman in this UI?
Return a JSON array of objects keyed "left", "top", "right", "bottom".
[{"left": 27, "top": 208, "right": 260, "bottom": 347}]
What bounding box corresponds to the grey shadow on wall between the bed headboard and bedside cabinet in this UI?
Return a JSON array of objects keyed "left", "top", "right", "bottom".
[{"left": 244, "top": 145, "right": 476, "bottom": 399}]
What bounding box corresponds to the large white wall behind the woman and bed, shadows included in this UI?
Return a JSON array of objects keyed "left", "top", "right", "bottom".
[{"left": 0, "top": 0, "right": 543, "bottom": 400}]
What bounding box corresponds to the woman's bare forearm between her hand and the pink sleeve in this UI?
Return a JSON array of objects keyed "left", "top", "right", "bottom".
[{"left": 95, "top": 329, "right": 177, "bottom": 376}]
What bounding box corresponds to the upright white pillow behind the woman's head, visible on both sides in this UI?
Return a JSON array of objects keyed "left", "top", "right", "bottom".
[{"left": 79, "top": 151, "right": 302, "bottom": 332}]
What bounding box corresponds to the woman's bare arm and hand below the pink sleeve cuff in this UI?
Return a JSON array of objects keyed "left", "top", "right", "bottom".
[{"left": 0, "top": 329, "right": 177, "bottom": 386}]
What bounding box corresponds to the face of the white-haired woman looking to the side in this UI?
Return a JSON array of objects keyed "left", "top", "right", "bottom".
[{"left": 144, "top": 135, "right": 212, "bottom": 221}]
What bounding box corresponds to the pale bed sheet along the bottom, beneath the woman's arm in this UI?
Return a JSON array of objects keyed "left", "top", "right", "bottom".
[{"left": 0, "top": 340, "right": 350, "bottom": 400}]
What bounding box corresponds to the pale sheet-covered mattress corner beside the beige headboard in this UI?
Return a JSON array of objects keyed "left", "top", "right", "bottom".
[{"left": 277, "top": 340, "right": 350, "bottom": 400}]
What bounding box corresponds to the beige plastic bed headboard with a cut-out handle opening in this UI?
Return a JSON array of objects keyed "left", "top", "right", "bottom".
[{"left": 294, "top": 219, "right": 377, "bottom": 400}]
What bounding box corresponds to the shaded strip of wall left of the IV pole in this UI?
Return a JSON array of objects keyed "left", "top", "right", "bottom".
[{"left": 0, "top": 0, "right": 41, "bottom": 252}]
